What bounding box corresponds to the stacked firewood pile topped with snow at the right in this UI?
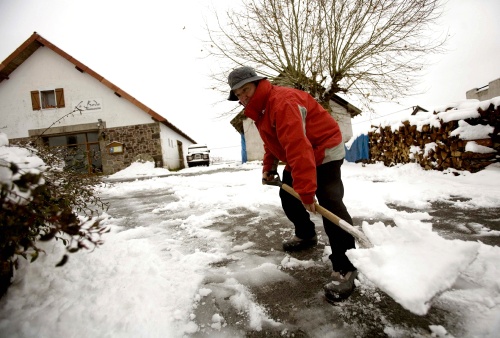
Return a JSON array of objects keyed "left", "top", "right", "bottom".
[{"left": 368, "top": 104, "right": 500, "bottom": 172}]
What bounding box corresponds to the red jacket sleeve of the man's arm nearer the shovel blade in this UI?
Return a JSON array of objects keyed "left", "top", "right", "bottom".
[{"left": 275, "top": 97, "right": 317, "bottom": 204}]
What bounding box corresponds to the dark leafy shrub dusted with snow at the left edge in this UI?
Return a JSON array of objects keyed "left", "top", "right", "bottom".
[{"left": 0, "top": 137, "right": 108, "bottom": 297}]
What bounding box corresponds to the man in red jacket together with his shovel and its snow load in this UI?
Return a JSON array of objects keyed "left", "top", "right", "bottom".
[{"left": 228, "top": 67, "right": 488, "bottom": 315}]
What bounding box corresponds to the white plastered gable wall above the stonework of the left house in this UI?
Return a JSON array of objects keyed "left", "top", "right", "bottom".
[{"left": 0, "top": 47, "right": 152, "bottom": 138}]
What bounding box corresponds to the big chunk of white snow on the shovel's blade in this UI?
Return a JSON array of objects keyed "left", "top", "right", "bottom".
[{"left": 348, "top": 217, "right": 479, "bottom": 315}]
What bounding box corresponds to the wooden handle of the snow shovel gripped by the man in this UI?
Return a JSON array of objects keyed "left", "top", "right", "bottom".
[{"left": 262, "top": 172, "right": 373, "bottom": 249}]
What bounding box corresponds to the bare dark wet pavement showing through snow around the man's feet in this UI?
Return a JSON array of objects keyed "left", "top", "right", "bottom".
[{"left": 188, "top": 203, "right": 500, "bottom": 337}]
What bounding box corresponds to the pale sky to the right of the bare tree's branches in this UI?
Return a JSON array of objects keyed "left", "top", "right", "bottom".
[{"left": 353, "top": 0, "right": 500, "bottom": 134}]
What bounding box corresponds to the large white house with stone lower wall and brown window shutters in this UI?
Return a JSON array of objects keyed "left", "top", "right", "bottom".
[{"left": 0, "top": 32, "right": 196, "bottom": 174}]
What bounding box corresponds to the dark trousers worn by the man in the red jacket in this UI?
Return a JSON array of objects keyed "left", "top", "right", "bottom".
[{"left": 280, "top": 160, "right": 355, "bottom": 272}]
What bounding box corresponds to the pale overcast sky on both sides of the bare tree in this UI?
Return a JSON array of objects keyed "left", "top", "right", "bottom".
[{"left": 0, "top": 0, "right": 500, "bottom": 153}]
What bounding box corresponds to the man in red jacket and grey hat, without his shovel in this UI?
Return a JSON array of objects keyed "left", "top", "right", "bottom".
[{"left": 228, "top": 67, "right": 357, "bottom": 301}]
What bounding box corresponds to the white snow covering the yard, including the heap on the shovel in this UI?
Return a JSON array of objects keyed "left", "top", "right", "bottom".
[{"left": 0, "top": 163, "right": 500, "bottom": 337}]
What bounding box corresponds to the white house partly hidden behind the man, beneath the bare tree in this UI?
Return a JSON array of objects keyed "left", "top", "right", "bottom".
[{"left": 231, "top": 95, "right": 361, "bottom": 161}]
